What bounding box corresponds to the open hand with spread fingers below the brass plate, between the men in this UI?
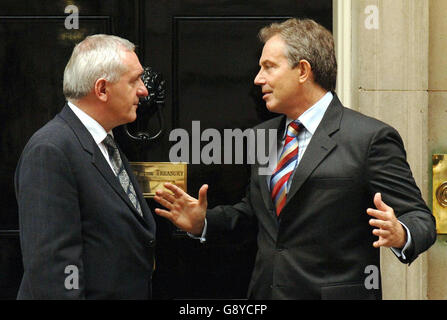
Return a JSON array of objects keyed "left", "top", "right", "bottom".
[{"left": 154, "top": 183, "right": 208, "bottom": 235}]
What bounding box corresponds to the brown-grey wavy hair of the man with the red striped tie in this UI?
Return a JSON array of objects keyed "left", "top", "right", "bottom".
[{"left": 259, "top": 18, "right": 337, "bottom": 91}]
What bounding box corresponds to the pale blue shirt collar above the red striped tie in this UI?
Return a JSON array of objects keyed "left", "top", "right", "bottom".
[{"left": 283, "top": 91, "right": 334, "bottom": 139}]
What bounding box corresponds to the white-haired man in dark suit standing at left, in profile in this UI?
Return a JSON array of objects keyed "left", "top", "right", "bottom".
[{"left": 15, "top": 35, "right": 155, "bottom": 299}]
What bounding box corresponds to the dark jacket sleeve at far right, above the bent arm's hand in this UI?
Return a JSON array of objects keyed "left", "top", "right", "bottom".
[{"left": 367, "top": 127, "right": 436, "bottom": 263}]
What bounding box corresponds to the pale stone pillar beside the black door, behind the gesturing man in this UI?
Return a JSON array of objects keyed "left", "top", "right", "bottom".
[{"left": 334, "top": 0, "right": 432, "bottom": 299}]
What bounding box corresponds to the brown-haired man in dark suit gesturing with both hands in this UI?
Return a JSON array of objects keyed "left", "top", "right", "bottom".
[{"left": 156, "top": 19, "right": 436, "bottom": 299}]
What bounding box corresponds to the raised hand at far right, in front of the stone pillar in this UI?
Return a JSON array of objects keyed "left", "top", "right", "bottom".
[{"left": 366, "top": 193, "right": 407, "bottom": 248}]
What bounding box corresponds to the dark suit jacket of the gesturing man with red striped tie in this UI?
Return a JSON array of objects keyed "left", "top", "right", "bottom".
[{"left": 207, "top": 94, "right": 436, "bottom": 299}]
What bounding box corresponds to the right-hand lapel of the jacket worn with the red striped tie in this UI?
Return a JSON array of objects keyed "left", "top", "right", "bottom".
[{"left": 286, "top": 94, "right": 343, "bottom": 205}]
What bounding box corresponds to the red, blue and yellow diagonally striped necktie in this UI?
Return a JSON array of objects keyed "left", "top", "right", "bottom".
[{"left": 270, "top": 120, "right": 301, "bottom": 216}]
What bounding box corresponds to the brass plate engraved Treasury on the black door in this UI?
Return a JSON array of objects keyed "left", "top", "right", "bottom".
[{"left": 129, "top": 162, "right": 187, "bottom": 198}]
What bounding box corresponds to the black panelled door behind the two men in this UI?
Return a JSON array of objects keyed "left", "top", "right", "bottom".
[{"left": 0, "top": 0, "right": 332, "bottom": 299}]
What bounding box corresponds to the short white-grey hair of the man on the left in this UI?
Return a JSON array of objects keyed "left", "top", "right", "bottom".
[{"left": 63, "top": 34, "right": 135, "bottom": 100}]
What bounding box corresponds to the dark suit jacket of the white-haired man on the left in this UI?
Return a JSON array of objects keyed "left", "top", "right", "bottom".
[{"left": 15, "top": 105, "right": 155, "bottom": 299}]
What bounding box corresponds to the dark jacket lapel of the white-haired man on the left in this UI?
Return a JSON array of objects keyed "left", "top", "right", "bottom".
[{"left": 59, "top": 105, "right": 148, "bottom": 226}]
